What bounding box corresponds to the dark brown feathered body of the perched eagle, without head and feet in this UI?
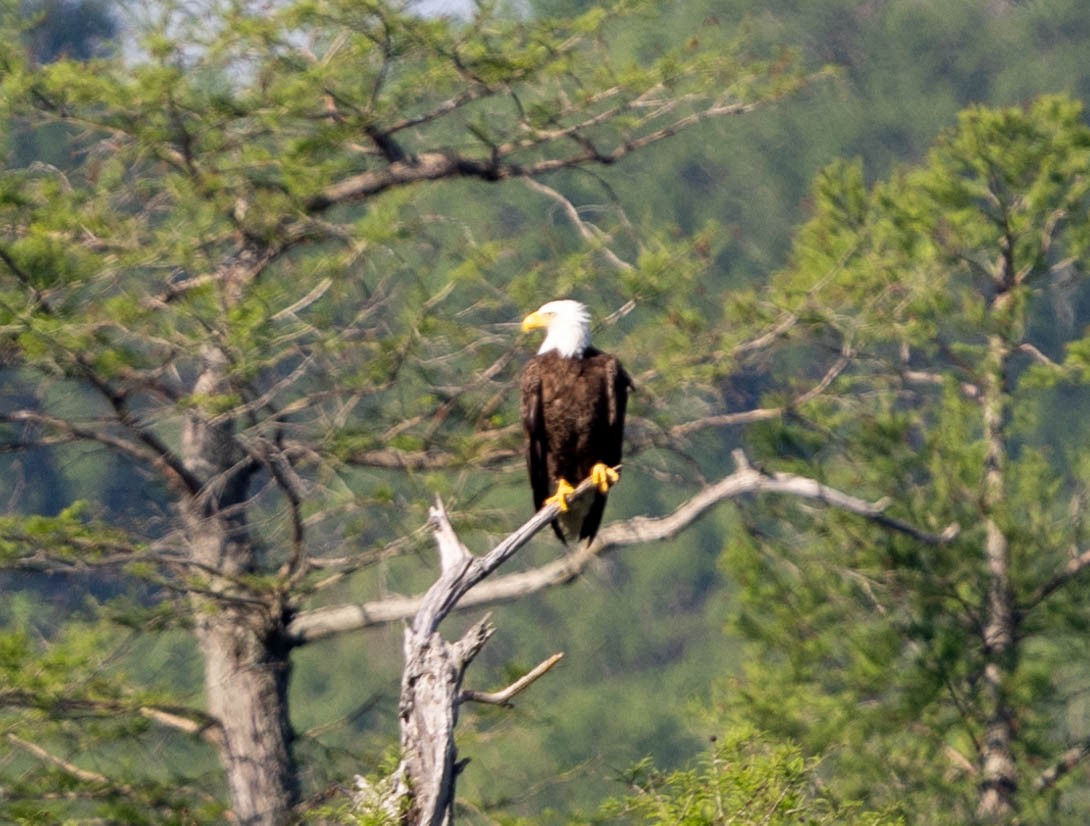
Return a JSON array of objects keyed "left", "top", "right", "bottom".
[{"left": 521, "top": 348, "right": 631, "bottom": 543}]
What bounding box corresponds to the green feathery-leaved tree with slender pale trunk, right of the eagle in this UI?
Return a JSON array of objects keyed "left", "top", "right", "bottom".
[{"left": 727, "top": 97, "right": 1090, "bottom": 823}]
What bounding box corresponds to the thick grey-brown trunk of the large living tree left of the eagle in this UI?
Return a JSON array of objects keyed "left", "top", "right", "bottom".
[{"left": 182, "top": 353, "right": 299, "bottom": 826}]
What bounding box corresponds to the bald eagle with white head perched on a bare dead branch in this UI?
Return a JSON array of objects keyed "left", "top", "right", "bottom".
[{"left": 521, "top": 300, "right": 632, "bottom": 544}]
